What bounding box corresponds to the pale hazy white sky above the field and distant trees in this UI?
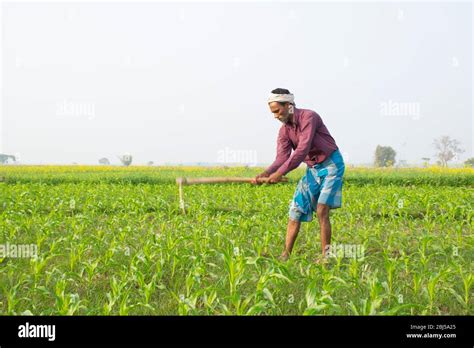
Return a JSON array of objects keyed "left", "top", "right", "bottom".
[{"left": 0, "top": 1, "right": 474, "bottom": 165}]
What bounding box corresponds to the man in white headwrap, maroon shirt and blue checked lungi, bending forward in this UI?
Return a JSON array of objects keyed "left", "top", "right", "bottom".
[{"left": 252, "top": 88, "right": 345, "bottom": 262}]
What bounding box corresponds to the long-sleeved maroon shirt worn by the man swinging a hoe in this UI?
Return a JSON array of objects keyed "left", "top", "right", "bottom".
[{"left": 265, "top": 107, "right": 338, "bottom": 175}]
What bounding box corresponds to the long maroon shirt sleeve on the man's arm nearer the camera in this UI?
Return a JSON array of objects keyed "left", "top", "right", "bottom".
[{"left": 277, "top": 113, "right": 320, "bottom": 175}]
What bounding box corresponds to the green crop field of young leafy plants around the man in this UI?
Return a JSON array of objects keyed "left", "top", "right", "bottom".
[{"left": 0, "top": 166, "right": 474, "bottom": 315}]
